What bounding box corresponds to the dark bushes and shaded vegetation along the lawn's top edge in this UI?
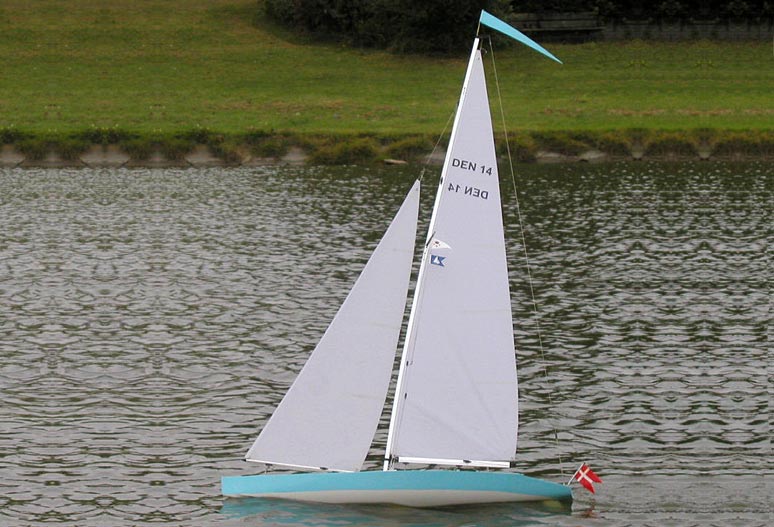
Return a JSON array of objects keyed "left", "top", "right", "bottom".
[{"left": 259, "top": 0, "right": 774, "bottom": 53}]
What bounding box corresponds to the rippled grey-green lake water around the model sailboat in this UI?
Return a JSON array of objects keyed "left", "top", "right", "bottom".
[{"left": 0, "top": 163, "right": 774, "bottom": 527}]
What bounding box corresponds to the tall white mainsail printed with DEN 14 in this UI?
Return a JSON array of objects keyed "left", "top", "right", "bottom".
[{"left": 386, "top": 39, "right": 518, "bottom": 467}]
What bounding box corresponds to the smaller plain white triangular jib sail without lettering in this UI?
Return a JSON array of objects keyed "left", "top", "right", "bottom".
[{"left": 246, "top": 181, "right": 419, "bottom": 471}]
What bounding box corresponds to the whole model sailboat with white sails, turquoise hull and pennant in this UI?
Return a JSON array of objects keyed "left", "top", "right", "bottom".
[{"left": 222, "top": 12, "right": 572, "bottom": 506}]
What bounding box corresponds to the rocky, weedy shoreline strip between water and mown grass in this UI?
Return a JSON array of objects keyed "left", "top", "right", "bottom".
[{"left": 0, "top": 129, "right": 774, "bottom": 168}]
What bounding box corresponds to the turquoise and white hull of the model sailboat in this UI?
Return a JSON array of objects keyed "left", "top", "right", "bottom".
[{"left": 221, "top": 470, "right": 572, "bottom": 507}]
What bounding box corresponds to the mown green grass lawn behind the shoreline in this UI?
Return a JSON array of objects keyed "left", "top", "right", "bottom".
[{"left": 0, "top": 0, "right": 774, "bottom": 136}]
